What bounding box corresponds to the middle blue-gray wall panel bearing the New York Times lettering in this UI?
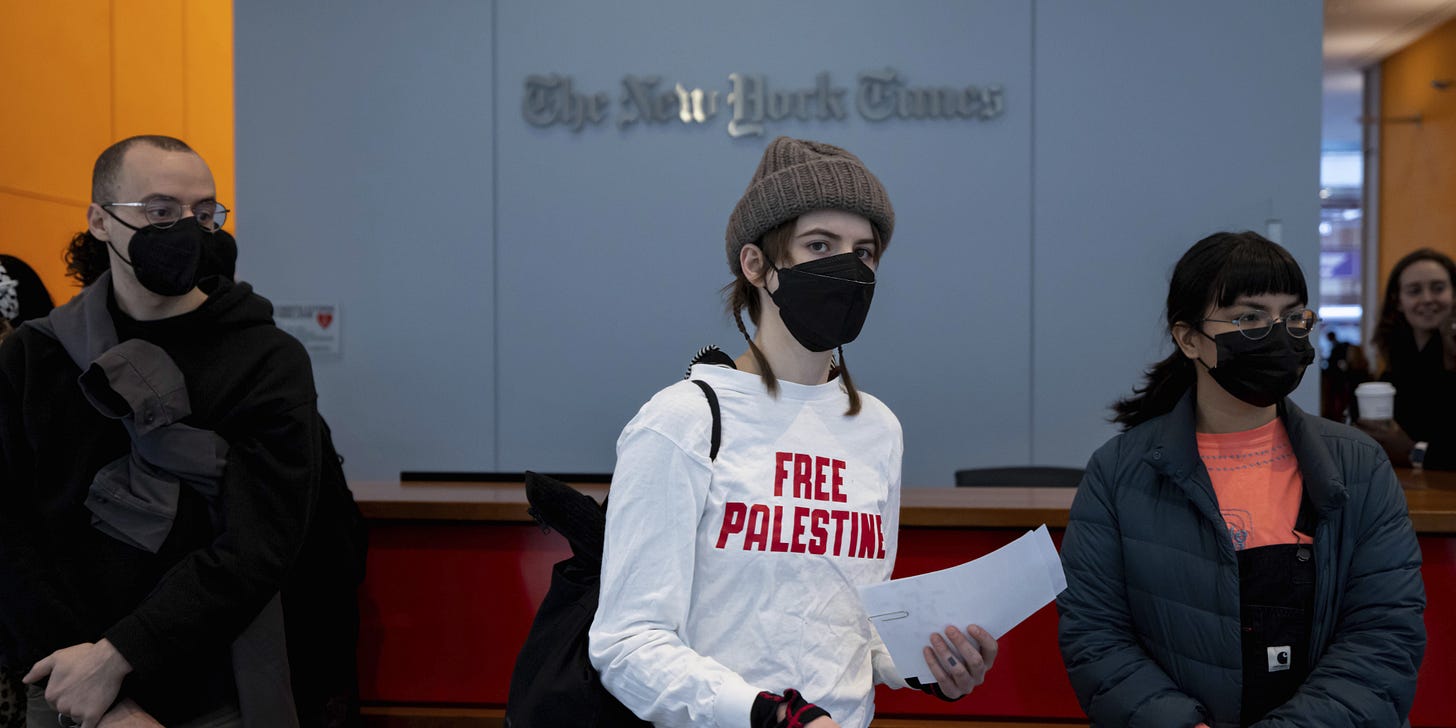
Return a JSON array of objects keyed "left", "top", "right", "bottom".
[{"left": 498, "top": 0, "right": 1031, "bottom": 483}]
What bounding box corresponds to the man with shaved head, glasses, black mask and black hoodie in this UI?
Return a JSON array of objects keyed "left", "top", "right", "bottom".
[{"left": 0, "top": 137, "right": 320, "bottom": 728}]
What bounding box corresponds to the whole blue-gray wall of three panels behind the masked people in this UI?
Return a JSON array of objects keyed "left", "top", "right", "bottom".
[{"left": 234, "top": 0, "right": 1321, "bottom": 485}]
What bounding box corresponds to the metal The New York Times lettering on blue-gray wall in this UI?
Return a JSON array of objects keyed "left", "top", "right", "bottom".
[{"left": 521, "top": 68, "right": 1006, "bottom": 137}]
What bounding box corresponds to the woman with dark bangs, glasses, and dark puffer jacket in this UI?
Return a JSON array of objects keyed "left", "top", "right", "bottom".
[{"left": 1057, "top": 233, "right": 1425, "bottom": 728}]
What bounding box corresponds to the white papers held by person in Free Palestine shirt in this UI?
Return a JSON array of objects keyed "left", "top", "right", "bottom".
[{"left": 859, "top": 526, "right": 1067, "bottom": 683}]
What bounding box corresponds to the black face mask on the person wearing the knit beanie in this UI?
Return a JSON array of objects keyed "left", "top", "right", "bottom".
[{"left": 769, "top": 253, "right": 875, "bottom": 351}]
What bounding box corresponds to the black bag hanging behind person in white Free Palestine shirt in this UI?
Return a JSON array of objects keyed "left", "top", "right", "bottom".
[{"left": 505, "top": 380, "right": 722, "bottom": 728}]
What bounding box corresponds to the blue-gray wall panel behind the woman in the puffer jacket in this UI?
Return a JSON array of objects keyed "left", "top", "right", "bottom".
[{"left": 1032, "top": 0, "right": 1321, "bottom": 464}]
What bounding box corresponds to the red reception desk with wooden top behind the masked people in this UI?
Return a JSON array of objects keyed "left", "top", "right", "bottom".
[{"left": 352, "top": 472, "right": 1456, "bottom": 728}]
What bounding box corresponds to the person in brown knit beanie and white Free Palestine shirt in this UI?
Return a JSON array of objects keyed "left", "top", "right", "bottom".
[{"left": 590, "top": 137, "right": 997, "bottom": 728}]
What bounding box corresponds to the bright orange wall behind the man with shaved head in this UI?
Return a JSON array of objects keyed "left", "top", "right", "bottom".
[{"left": 0, "top": 0, "right": 234, "bottom": 301}]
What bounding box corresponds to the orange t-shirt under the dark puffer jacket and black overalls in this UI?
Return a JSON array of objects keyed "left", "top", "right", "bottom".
[{"left": 1197, "top": 418, "right": 1312, "bottom": 550}]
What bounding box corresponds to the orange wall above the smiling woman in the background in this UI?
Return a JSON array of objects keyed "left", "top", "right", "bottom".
[{"left": 1376, "top": 12, "right": 1456, "bottom": 295}]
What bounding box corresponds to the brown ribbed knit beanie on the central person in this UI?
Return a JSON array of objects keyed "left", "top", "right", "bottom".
[{"left": 727, "top": 137, "right": 895, "bottom": 275}]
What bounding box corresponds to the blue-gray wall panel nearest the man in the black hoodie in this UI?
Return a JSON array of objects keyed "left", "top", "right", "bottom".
[{"left": 234, "top": 0, "right": 495, "bottom": 479}]
